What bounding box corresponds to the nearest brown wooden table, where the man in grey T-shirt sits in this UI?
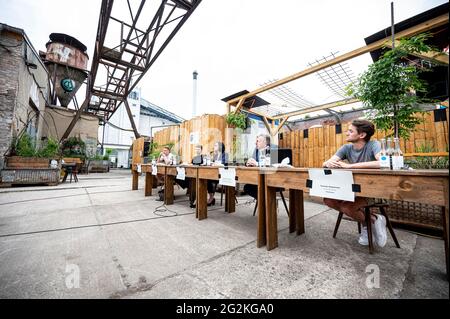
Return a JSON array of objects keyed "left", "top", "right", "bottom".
[{"left": 265, "top": 168, "right": 449, "bottom": 276}]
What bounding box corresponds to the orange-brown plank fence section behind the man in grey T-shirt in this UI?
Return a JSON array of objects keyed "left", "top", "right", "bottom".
[{"left": 279, "top": 108, "right": 449, "bottom": 167}]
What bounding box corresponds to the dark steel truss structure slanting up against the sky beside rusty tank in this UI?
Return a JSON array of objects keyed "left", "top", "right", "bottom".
[{"left": 61, "top": 0, "right": 201, "bottom": 140}]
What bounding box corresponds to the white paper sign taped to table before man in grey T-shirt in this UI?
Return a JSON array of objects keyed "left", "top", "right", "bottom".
[{"left": 309, "top": 169, "right": 355, "bottom": 202}]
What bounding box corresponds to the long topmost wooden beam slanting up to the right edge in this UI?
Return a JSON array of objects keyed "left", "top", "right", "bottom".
[{"left": 228, "top": 14, "right": 448, "bottom": 104}]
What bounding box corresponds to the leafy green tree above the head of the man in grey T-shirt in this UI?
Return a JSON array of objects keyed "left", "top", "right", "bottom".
[{"left": 347, "top": 34, "right": 432, "bottom": 138}]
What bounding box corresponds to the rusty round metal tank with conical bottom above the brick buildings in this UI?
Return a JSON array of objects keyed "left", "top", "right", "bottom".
[{"left": 45, "top": 33, "right": 89, "bottom": 107}]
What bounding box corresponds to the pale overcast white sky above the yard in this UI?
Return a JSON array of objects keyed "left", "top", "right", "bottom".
[{"left": 0, "top": 0, "right": 447, "bottom": 119}]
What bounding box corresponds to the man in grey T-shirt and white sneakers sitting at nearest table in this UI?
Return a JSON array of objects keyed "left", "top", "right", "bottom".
[{"left": 323, "top": 120, "right": 387, "bottom": 247}]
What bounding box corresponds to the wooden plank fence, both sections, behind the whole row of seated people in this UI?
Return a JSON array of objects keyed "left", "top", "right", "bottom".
[{"left": 153, "top": 108, "right": 449, "bottom": 167}]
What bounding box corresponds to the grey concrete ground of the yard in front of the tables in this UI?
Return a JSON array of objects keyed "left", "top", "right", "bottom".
[{"left": 0, "top": 171, "right": 449, "bottom": 299}]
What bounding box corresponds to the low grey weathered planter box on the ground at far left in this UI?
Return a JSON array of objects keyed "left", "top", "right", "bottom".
[{"left": 1, "top": 168, "right": 60, "bottom": 185}]
